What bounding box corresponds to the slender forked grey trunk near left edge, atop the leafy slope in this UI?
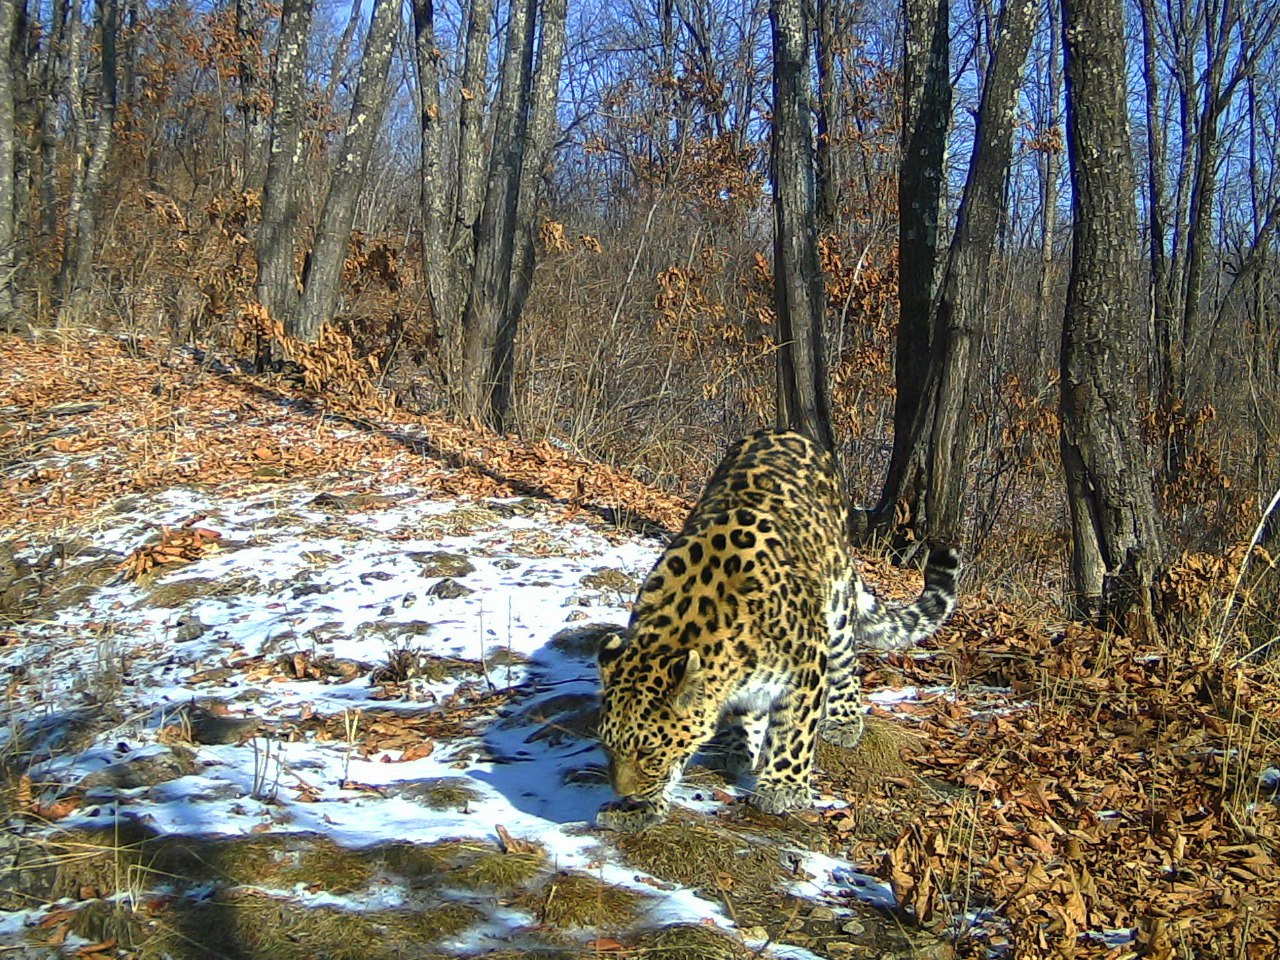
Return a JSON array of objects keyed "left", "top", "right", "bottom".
[{"left": 58, "top": 0, "right": 120, "bottom": 319}]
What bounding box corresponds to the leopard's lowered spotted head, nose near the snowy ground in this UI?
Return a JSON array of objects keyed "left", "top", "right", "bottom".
[{"left": 598, "top": 634, "right": 716, "bottom": 799}]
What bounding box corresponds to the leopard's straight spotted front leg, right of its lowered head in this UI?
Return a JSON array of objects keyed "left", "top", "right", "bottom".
[{"left": 751, "top": 671, "right": 826, "bottom": 814}]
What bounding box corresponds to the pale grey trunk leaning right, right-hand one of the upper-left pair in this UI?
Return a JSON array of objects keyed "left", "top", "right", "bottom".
[{"left": 293, "top": 0, "right": 401, "bottom": 340}]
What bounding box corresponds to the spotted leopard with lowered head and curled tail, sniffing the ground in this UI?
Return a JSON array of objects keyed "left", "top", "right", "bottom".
[{"left": 595, "top": 430, "right": 960, "bottom": 832}]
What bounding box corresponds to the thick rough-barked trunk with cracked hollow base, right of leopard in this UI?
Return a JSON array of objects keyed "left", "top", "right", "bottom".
[{"left": 1061, "top": 0, "right": 1162, "bottom": 630}]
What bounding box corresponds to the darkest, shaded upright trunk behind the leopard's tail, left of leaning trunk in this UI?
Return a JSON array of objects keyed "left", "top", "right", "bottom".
[{"left": 872, "top": 0, "right": 951, "bottom": 530}]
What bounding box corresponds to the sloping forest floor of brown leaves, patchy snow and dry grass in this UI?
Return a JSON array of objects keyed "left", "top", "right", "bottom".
[{"left": 0, "top": 335, "right": 1280, "bottom": 960}]
